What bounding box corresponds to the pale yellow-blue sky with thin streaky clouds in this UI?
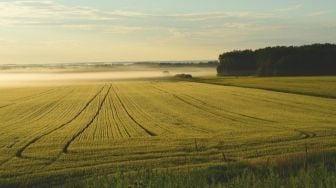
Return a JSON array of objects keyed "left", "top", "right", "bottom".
[{"left": 0, "top": 0, "right": 336, "bottom": 64}]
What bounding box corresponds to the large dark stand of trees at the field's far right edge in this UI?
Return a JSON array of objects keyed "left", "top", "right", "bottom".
[{"left": 217, "top": 44, "right": 336, "bottom": 76}]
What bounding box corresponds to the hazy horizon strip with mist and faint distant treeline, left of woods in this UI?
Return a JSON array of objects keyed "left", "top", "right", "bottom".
[{"left": 0, "top": 63, "right": 216, "bottom": 87}]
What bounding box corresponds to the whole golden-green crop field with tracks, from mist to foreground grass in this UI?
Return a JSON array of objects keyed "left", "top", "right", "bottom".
[{"left": 0, "top": 77, "right": 336, "bottom": 186}]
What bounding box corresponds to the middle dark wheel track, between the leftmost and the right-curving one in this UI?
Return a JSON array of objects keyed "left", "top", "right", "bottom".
[{"left": 62, "top": 85, "right": 112, "bottom": 154}]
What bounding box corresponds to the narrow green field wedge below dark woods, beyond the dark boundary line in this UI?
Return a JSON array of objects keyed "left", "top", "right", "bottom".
[{"left": 193, "top": 76, "right": 336, "bottom": 98}]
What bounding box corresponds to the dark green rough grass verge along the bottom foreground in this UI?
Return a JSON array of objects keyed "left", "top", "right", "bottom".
[{"left": 65, "top": 153, "right": 336, "bottom": 188}]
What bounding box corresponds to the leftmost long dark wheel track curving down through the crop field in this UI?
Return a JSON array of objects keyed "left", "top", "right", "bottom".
[{"left": 15, "top": 86, "right": 105, "bottom": 158}]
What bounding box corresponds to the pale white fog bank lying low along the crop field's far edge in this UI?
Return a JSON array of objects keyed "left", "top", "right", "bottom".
[{"left": 0, "top": 68, "right": 215, "bottom": 87}]
